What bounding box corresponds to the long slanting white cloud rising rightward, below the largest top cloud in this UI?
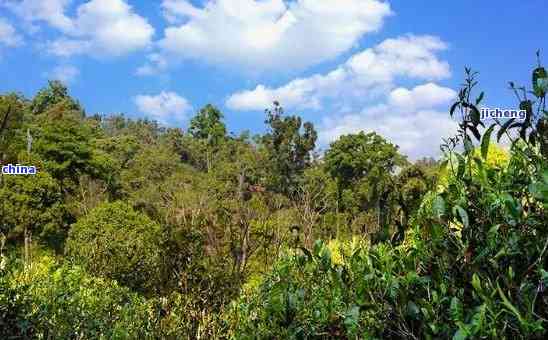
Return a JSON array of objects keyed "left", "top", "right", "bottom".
[{"left": 226, "top": 35, "right": 450, "bottom": 110}]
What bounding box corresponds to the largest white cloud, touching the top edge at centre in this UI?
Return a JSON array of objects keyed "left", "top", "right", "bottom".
[{"left": 159, "top": 0, "right": 392, "bottom": 71}]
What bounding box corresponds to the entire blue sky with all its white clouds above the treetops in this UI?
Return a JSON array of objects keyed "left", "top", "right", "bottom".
[{"left": 0, "top": 0, "right": 548, "bottom": 158}]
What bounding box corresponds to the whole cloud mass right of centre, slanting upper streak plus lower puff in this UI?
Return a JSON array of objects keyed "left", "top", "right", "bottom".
[{"left": 226, "top": 35, "right": 457, "bottom": 159}]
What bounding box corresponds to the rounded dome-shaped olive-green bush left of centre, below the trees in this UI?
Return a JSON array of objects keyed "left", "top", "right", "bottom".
[{"left": 65, "top": 202, "right": 162, "bottom": 292}]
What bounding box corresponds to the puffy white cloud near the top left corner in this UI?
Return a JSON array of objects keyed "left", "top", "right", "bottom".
[{"left": 6, "top": 0, "right": 154, "bottom": 57}]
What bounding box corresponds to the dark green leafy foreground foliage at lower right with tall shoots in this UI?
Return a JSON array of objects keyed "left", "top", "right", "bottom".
[{"left": 226, "top": 62, "right": 548, "bottom": 339}]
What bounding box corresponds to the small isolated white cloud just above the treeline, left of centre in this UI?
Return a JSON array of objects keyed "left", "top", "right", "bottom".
[{"left": 133, "top": 91, "right": 192, "bottom": 124}]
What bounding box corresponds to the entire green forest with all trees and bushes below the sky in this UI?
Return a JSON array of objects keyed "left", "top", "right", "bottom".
[{"left": 0, "top": 55, "right": 548, "bottom": 339}]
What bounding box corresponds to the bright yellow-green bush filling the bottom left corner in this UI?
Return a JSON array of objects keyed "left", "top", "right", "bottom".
[{"left": 0, "top": 256, "right": 155, "bottom": 339}]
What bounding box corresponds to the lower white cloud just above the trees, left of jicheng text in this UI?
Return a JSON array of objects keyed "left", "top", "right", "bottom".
[{"left": 319, "top": 83, "right": 457, "bottom": 159}]
